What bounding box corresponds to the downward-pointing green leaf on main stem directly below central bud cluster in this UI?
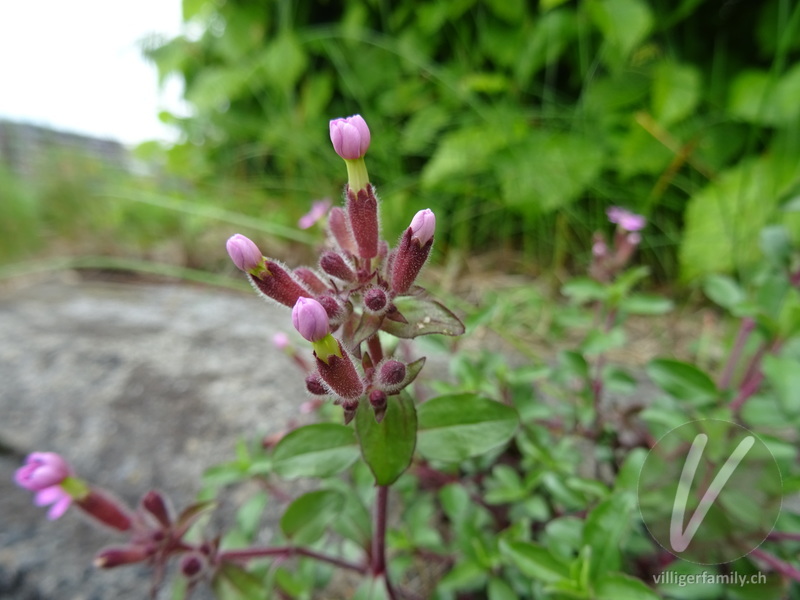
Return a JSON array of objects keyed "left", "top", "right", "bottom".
[{"left": 356, "top": 392, "right": 417, "bottom": 485}]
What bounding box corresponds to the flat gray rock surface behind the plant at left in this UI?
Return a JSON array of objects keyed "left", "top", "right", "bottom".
[{"left": 0, "top": 276, "right": 306, "bottom": 600}]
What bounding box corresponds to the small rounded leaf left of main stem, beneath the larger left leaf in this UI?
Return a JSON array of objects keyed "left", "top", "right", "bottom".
[{"left": 280, "top": 490, "right": 344, "bottom": 546}]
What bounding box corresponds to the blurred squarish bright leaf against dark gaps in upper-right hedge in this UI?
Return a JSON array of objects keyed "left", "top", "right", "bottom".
[{"left": 653, "top": 62, "right": 700, "bottom": 125}]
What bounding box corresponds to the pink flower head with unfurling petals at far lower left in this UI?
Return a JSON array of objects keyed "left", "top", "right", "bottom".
[{"left": 14, "top": 452, "right": 72, "bottom": 520}]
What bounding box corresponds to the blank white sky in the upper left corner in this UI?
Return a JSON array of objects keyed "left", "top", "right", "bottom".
[{"left": 0, "top": 0, "right": 185, "bottom": 144}]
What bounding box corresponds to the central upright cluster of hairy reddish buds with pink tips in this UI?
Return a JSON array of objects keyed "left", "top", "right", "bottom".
[{"left": 222, "top": 115, "right": 444, "bottom": 421}]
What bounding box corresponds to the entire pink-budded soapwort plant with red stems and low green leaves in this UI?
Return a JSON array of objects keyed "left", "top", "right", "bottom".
[{"left": 16, "top": 115, "right": 800, "bottom": 600}]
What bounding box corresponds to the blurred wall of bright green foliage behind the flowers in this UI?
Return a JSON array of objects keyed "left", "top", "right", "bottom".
[{"left": 136, "top": 0, "right": 800, "bottom": 279}]
